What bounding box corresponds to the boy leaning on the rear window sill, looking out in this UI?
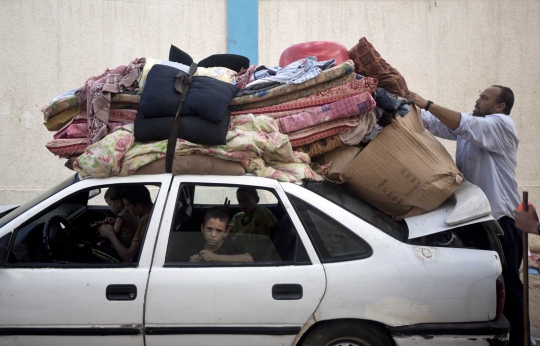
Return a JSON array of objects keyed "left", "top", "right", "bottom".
[{"left": 189, "top": 207, "right": 253, "bottom": 262}]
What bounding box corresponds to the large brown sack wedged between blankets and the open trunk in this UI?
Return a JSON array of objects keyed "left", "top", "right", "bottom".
[{"left": 341, "top": 106, "right": 464, "bottom": 219}]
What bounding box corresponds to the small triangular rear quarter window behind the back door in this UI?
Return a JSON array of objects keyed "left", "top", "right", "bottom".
[{"left": 289, "top": 195, "right": 372, "bottom": 263}]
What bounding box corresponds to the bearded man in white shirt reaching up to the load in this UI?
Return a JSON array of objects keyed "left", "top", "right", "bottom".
[{"left": 407, "top": 85, "right": 523, "bottom": 345}]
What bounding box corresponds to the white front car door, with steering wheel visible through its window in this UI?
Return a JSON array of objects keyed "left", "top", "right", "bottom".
[{"left": 0, "top": 175, "right": 171, "bottom": 346}]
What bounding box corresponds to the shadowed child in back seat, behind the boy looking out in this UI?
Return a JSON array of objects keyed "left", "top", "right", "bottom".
[{"left": 229, "top": 186, "right": 279, "bottom": 236}]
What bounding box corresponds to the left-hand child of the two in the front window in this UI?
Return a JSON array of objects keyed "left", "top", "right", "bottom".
[{"left": 97, "top": 186, "right": 139, "bottom": 248}]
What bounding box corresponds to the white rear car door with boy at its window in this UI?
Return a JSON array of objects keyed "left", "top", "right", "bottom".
[{"left": 145, "top": 176, "right": 326, "bottom": 346}]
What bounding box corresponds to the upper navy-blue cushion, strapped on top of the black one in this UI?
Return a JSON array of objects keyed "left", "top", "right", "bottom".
[{"left": 139, "top": 65, "right": 240, "bottom": 122}]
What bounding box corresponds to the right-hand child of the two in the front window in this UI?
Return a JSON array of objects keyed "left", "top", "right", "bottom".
[{"left": 99, "top": 185, "right": 154, "bottom": 262}]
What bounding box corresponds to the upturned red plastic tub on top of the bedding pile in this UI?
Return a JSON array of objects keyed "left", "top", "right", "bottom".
[{"left": 279, "top": 41, "right": 349, "bottom": 67}]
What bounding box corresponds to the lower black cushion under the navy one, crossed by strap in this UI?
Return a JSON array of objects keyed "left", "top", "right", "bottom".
[{"left": 134, "top": 109, "right": 231, "bottom": 145}]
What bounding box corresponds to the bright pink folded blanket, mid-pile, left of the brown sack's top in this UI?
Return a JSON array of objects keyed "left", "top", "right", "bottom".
[{"left": 278, "top": 93, "right": 375, "bottom": 133}]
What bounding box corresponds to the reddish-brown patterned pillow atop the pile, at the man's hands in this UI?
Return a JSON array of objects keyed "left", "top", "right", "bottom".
[{"left": 349, "top": 37, "right": 408, "bottom": 97}]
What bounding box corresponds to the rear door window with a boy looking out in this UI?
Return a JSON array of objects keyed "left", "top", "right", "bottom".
[{"left": 165, "top": 184, "right": 311, "bottom": 267}]
